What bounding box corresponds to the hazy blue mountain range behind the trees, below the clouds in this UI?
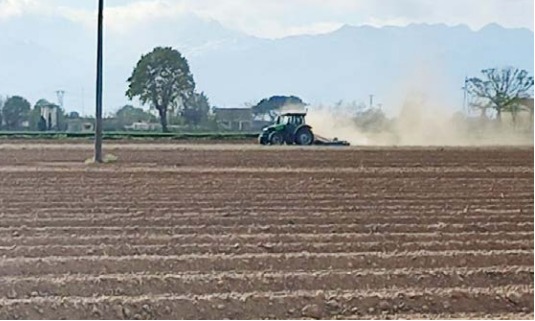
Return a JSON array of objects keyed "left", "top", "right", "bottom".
[{"left": 0, "top": 15, "right": 534, "bottom": 114}]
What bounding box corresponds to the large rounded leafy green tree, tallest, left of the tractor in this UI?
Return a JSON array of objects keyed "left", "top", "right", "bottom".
[{"left": 126, "top": 47, "right": 195, "bottom": 132}]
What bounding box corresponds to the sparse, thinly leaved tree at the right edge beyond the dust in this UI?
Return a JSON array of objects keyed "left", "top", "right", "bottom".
[{"left": 467, "top": 68, "right": 533, "bottom": 121}]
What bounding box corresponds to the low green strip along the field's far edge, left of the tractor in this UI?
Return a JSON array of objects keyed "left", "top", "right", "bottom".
[{"left": 0, "top": 131, "right": 258, "bottom": 140}]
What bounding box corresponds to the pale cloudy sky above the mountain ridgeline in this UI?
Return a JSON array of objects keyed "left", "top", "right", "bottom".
[{"left": 0, "top": 0, "right": 534, "bottom": 38}]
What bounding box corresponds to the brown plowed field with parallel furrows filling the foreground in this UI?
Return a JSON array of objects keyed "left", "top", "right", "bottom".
[{"left": 0, "top": 142, "right": 534, "bottom": 319}]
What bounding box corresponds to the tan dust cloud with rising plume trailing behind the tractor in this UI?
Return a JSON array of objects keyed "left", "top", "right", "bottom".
[{"left": 307, "top": 69, "right": 533, "bottom": 146}]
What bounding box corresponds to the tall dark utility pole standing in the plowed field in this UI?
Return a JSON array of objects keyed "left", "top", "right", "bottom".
[{"left": 95, "top": 0, "right": 104, "bottom": 163}]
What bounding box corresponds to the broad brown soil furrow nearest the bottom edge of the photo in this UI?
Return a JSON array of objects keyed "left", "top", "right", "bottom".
[{"left": 0, "top": 286, "right": 533, "bottom": 319}]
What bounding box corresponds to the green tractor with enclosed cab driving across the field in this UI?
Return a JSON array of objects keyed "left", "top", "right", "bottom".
[{"left": 258, "top": 113, "right": 314, "bottom": 145}]
